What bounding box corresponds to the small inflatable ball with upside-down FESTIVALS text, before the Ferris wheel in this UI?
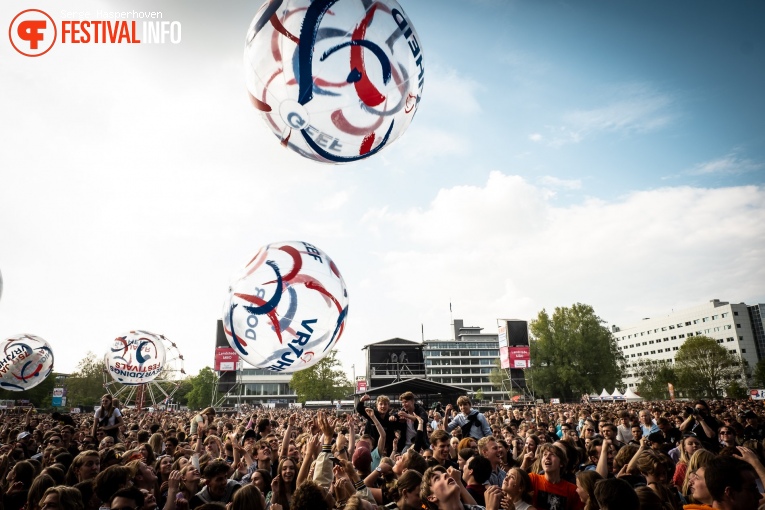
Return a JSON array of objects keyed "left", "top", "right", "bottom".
[{"left": 104, "top": 330, "right": 165, "bottom": 385}]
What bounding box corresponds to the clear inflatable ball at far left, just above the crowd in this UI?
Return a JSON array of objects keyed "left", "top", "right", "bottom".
[{"left": 0, "top": 334, "right": 53, "bottom": 391}]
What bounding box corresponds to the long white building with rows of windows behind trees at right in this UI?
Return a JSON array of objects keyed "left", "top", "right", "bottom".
[{"left": 611, "top": 299, "right": 765, "bottom": 388}]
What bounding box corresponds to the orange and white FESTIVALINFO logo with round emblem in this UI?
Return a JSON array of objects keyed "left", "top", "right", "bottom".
[{"left": 8, "top": 9, "right": 181, "bottom": 57}]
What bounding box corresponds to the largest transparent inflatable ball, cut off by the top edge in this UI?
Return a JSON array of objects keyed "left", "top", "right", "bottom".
[{"left": 244, "top": 0, "right": 425, "bottom": 163}]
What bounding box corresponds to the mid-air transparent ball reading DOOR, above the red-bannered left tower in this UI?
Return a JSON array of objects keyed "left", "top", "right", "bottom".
[{"left": 223, "top": 241, "right": 348, "bottom": 373}]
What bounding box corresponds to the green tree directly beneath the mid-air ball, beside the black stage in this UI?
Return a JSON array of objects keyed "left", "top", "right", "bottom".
[{"left": 290, "top": 351, "right": 353, "bottom": 404}]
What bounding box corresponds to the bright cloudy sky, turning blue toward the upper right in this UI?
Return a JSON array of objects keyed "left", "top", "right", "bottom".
[{"left": 0, "top": 0, "right": 765, "bottom": 380}]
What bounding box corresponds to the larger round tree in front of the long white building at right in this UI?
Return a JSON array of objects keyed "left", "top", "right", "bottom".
[{"left": 675, "top": 335, "right": 745, "bottom": 398}]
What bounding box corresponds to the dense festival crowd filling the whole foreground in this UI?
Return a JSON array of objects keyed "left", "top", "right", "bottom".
[{"left": 0, "top": 392, "right": 765, "bottom": 510}]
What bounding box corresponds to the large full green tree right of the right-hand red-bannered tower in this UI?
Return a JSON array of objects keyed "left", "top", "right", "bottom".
[{"left": 527, "top": 303, "right": 625, "bottom": 400}]
